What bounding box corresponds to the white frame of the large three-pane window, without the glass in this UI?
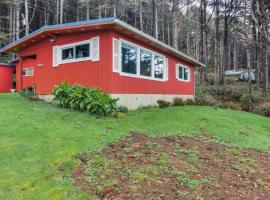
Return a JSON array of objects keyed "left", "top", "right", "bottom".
[{"left": 119, "top": 39, "right": 169, "bottom": 82}]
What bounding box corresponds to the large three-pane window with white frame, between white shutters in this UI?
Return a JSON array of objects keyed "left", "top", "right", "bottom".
[{"left": 120, "top": 40, "right": 167, "bottom": 80}]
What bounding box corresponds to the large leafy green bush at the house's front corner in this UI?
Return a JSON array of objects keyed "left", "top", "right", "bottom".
[{"left": 52, "top": 82, "right": 117, "bottom": 116}]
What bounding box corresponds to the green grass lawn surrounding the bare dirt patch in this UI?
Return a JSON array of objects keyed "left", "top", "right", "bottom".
[{"left": 0, "top": 94, "right": 270, "bottom": 200}]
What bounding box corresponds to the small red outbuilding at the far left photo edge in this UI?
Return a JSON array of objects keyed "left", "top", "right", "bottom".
[{"left": 0, "top": 62, "right": 15, "bottom": 93}]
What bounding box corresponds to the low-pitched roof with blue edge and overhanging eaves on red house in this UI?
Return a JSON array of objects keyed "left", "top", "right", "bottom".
[{"left": 0, "top": 17, "right": 205, "bottom": 66}]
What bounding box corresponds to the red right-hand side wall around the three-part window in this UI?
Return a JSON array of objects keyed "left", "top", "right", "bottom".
[{"left": 111, "top": 33, "right": 194, "bottom": 95}]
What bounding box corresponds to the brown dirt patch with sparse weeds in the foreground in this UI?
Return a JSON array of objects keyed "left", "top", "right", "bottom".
[{"left": 72, "top": 133, "right": 270, "bottom": 200}]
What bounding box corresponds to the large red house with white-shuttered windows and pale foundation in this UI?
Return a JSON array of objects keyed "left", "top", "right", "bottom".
[{"left": 1, "top": 18, "right": 203, "bottom": 108}]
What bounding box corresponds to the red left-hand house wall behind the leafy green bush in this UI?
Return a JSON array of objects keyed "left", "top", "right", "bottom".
[{"left": 17, "top": 31, "right": 112, "bottom": 94}]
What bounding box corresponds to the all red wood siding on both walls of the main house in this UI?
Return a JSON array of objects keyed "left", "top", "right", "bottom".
[{"left": 17, "top": 28, "right": 194, "bottom": 95}]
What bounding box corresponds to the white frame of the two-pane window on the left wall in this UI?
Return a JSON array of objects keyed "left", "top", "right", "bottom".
[{"left": 59, "top": 39, "right": 93, "bottom": 64}]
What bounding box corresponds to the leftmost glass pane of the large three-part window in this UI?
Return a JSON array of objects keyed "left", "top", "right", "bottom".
[{"left": 122, "top": 43, "right": 137, "bottom": 74}]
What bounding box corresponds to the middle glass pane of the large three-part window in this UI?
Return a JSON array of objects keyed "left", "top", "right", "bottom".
[{"left": 140, "top": 50, "right": 152, "bottom": 76}]
